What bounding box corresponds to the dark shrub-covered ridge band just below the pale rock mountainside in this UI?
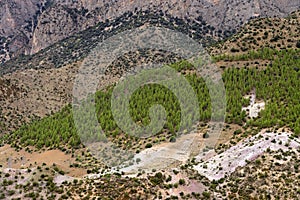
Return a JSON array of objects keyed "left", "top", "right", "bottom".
[{"left": 0, "top": 11, "right": 214, "bottom": 74}]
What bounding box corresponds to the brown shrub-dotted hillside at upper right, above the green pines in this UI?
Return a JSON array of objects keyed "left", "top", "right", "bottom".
[{"left": 209, "top": 11, "right": 300, "bottom": 55}]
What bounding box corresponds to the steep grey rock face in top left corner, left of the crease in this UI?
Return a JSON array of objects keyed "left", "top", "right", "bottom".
[{"left": 0, "top": 0, "right": 50, "bottom": 63}]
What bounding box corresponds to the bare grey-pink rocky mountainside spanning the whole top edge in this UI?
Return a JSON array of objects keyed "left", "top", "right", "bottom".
[{"left": 0, "top": 0, "right": 300, "bottom": 62}]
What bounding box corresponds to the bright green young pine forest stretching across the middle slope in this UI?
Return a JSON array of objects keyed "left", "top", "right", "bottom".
[{"left": 4, "top": 49, "right": 300, "bottom": 148}]
